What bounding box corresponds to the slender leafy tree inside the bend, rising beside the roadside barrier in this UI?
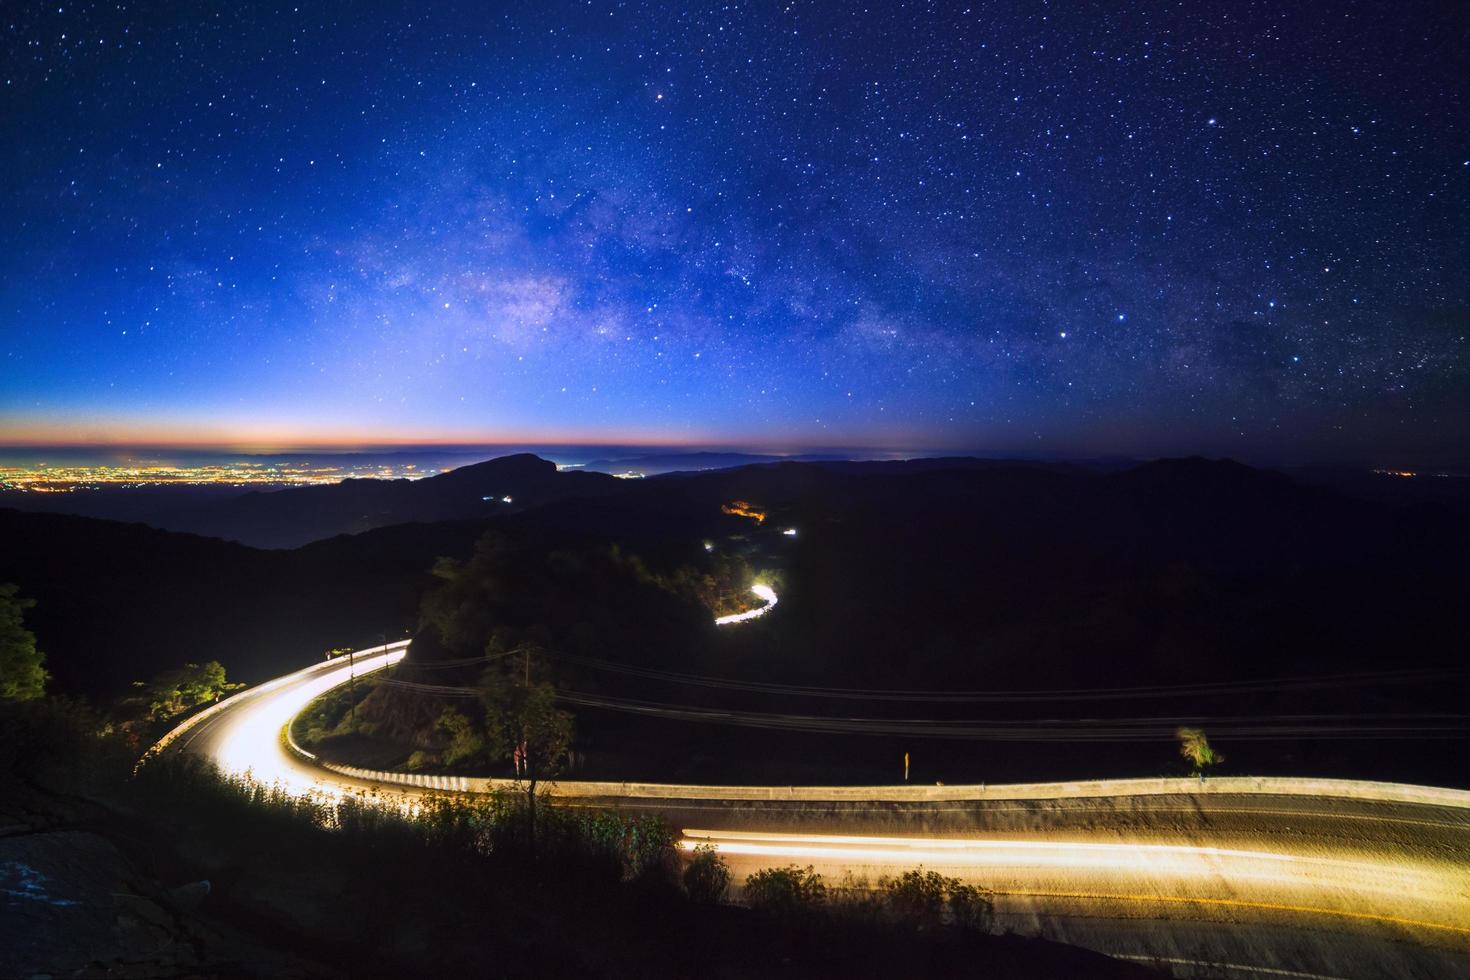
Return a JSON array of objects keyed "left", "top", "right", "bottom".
[{"left": 479, "top": 651, "right": 573, "bottom": 837}]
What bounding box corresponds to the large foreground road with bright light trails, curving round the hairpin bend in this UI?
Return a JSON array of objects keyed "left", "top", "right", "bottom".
[{"left": 156, "top": 644, "right": 1470, "bottom": 980}]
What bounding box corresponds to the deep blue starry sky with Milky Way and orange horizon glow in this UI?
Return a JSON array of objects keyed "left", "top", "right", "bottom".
[{"left": 0, "top": 0, "right": 1470, "bottom": 464}]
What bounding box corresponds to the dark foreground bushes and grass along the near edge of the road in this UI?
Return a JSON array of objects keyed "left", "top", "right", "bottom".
[{"left": 0, "top": 698, "right": 1147, "bottom": 979}]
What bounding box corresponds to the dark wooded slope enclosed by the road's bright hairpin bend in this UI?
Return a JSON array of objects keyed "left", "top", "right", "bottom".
[{"left": 293, "top": 529, "right": 779, "bottom": 781}]
